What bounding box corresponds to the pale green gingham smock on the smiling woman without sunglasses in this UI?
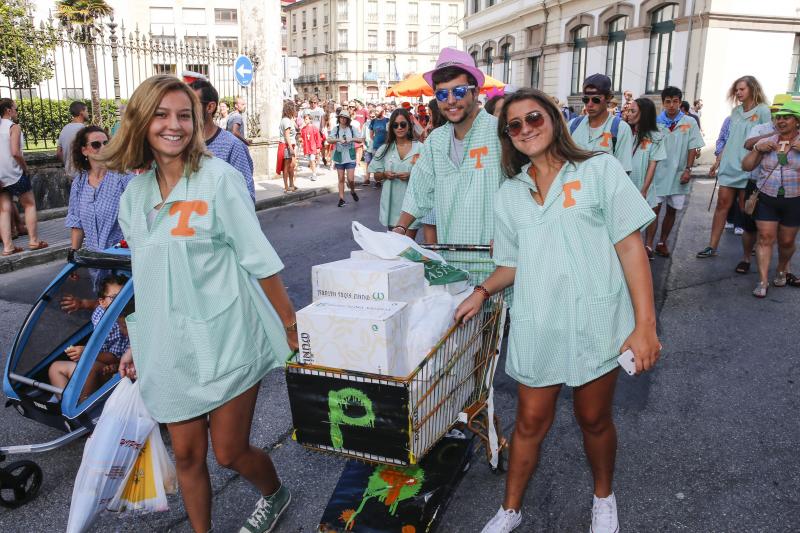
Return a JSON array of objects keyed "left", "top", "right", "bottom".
[{"left": 119, "top": 158, "right": 290, "bottom": 423}]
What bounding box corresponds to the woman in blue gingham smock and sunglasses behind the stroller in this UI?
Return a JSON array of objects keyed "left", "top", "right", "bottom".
[{"left": 62, "top": 126, "right": 133, "bottom": 296}]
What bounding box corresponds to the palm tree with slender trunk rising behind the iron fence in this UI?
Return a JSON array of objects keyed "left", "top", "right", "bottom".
[{"left": 56, "top": 0, "right": 114, "bottom": 125}]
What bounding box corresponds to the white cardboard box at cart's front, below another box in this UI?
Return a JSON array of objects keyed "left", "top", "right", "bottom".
[{"left": 297, "top": 298, "right": 407, "bottom": 375}]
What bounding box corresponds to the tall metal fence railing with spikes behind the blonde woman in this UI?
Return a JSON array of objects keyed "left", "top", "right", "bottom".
[{"left": 0, "top": 13, "right": 260, "bottom": 151}]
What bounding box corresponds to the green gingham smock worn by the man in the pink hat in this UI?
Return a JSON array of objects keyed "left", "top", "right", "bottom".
[{"left": 403, "top": 109, "right": 504, "bottom": 284}]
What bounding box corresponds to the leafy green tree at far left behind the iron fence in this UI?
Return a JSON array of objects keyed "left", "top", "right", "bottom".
[{"left": 0, "top": 0, "right": 56, "bottom": 88}]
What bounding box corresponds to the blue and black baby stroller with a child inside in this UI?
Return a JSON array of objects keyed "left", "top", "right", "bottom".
[{"left": 0, "top": 247, "right": 133, "bottom": 508}]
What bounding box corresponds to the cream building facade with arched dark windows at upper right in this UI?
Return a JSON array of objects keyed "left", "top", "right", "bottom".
[{"left": 461, "top": 0, "right": 800, "bottom": 158}]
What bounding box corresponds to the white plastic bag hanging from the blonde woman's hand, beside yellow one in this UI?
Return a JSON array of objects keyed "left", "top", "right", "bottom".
[{"left": 67, "top": 378, "right": 156, "bottom": 533}]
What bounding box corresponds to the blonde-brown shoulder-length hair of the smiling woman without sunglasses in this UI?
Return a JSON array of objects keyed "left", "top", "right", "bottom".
[{"left": 93, "top": 75, "right": 211, "bottom": 172}]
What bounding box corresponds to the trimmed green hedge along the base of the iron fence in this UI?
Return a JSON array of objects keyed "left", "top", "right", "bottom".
[{"left": 17, "top": 98, "right": 125, "bottom": 143}]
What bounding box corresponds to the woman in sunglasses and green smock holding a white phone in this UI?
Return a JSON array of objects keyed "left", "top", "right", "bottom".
[{"left": 456, "top": 89, "right": 660, "bottom": 533}]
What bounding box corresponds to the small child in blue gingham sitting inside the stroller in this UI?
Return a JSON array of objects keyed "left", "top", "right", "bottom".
[{"left": 48, "top": 274, "right": 133, "bottom": 401}]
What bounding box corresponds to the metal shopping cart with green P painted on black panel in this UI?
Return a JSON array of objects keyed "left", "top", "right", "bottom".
[{"left": 286, "top": 245, "right": 506, "bottom": 469}]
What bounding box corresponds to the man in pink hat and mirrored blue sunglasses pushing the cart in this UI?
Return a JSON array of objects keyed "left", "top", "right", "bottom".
[{"left": 394, "top": 48, "right": 503, "bottom": 285}]
